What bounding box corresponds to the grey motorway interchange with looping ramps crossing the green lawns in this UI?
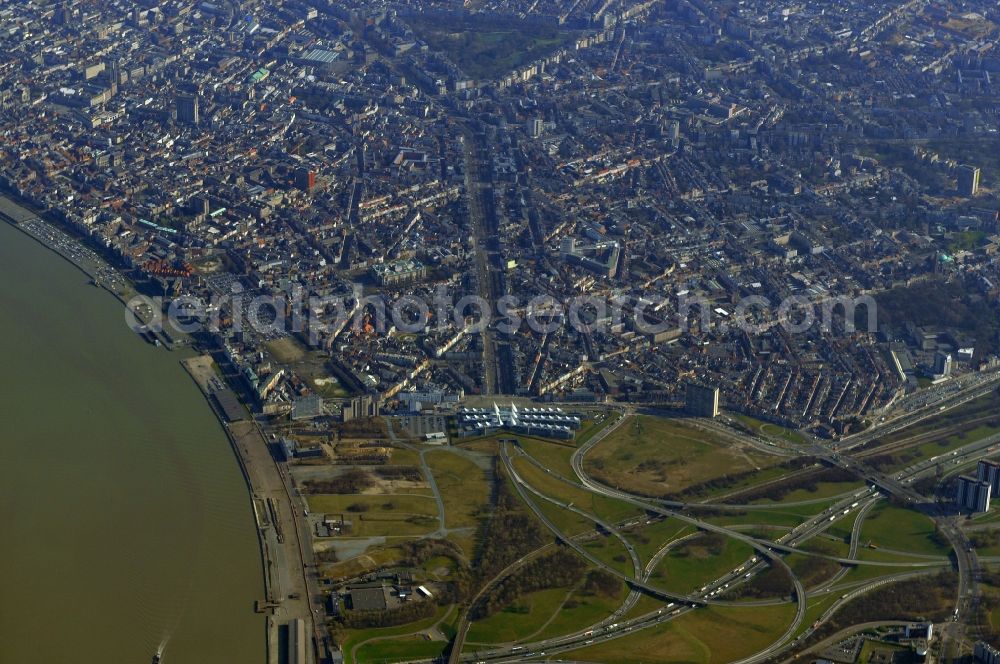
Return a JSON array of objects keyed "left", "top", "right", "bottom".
[{"left": 454, "top": 374, "right": 1000, "bottom": 664}]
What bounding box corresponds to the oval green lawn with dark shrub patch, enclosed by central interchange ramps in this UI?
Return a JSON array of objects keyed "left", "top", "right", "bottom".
[{"left": 650, "top": 533, "right": 754, "bottom": 594}]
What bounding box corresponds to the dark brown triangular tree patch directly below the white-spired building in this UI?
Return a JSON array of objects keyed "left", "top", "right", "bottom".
[{"left": 476, "top": 479, "right": 545, "bottom": 581}]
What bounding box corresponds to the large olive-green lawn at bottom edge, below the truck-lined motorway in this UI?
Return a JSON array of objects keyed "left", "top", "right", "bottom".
[{"left": 560, "top": 604, "right": 795, "bottom": 664}]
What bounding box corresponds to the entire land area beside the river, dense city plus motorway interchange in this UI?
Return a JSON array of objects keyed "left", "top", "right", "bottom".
[{"left": 0, "top": 0, "right": 1000, "bottom": 664}]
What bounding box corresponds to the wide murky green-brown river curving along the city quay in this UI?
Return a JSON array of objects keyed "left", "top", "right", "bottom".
[{"left": 0, "top": 221, "right": 265, "bottom": 664}]
